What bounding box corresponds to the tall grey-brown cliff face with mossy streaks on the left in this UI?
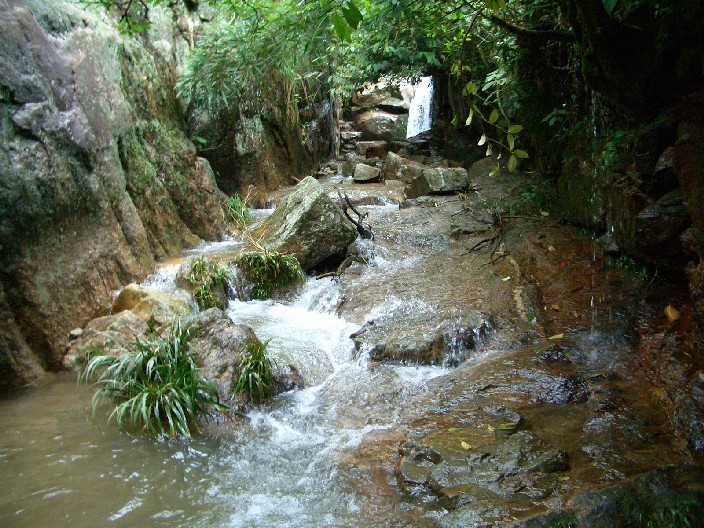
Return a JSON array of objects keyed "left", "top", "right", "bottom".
[{"left": 0, "top": 0, "right": 225, "bottom": 389}]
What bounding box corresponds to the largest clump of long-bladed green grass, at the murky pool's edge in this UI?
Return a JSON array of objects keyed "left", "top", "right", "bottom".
[{"left": 79, "top": 322, "right": 229, "bottom": 437}]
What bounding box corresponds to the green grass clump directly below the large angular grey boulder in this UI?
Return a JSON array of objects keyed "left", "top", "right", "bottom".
[{"left": 236, "top": 251, "right": 305, "bottom": 299}]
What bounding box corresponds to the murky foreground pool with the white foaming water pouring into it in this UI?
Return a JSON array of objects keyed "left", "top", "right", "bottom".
[{"left": 0, "top": 248, "right": 446, "bottom": 527}]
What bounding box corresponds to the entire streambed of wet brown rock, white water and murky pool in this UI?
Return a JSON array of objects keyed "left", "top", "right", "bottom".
[{"left": 0, "top": 162, "right": 704, "bottom": 527}]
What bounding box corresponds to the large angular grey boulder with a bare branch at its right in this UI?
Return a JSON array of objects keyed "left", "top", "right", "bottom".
[{"left": 253, "top": 176, "right": 357, "bottom": 270}]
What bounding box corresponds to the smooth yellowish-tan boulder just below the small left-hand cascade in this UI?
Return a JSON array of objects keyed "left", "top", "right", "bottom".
[{"left": 112, "top": 283, "right": 193, "bottom": 328}]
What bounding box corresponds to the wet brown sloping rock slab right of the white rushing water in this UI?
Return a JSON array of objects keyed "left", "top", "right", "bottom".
[{"left": 322, "top": 162, "right": 700, "bottom": 527}]
